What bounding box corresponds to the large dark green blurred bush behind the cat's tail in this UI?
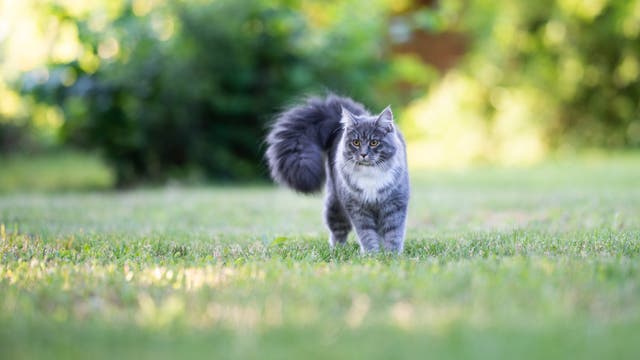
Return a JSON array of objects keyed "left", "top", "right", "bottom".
[{"left": 23, "top": 0, "right": 402, "bottom": 185}]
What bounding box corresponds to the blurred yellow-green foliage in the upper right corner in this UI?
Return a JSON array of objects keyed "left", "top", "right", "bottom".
[{"left": 430, "top": 0, "right": 640, "bottom": 147}]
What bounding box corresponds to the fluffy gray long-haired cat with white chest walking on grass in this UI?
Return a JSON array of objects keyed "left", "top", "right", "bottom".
[{"left": 266, "top": 95, "right": 409, "bottom": 253}]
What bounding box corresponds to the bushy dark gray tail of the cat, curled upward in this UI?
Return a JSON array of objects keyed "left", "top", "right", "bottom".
[{"left": 266, "top": 95, "right": 366, "bottom": 193}]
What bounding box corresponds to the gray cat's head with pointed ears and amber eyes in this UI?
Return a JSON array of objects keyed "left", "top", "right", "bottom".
[{"left": 341, "top": 106, "right": 398, "bottom": 166}]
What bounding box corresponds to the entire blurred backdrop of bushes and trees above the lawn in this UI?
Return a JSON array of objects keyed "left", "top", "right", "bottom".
[{"left": 0, "top": 0, "right": 640, "bottom": 191}]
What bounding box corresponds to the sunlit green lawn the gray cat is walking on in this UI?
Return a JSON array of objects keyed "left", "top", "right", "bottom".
[{"left": 0, "top": 155, "right": 640, "bottom": 359}]
